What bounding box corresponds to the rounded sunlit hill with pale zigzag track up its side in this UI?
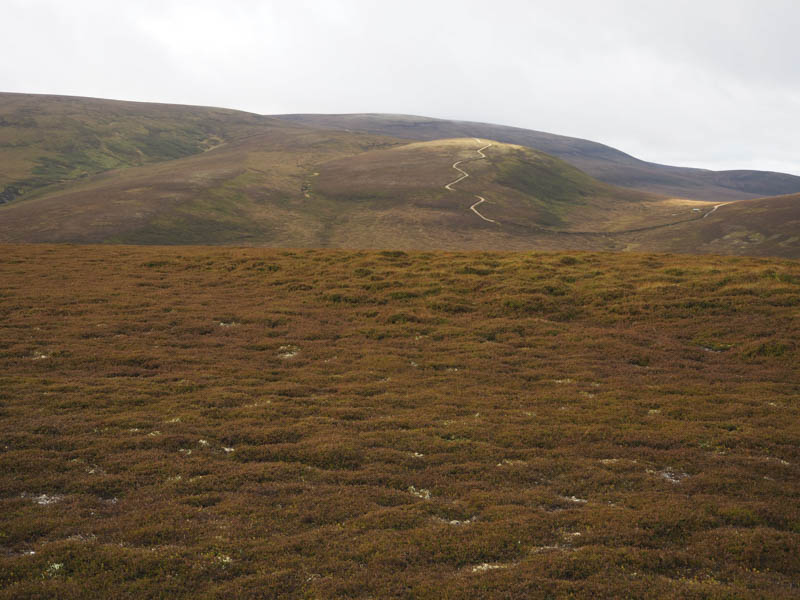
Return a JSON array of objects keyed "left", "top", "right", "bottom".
[{"left": 313, "top": 138, "right": 691, "bottom": 241}]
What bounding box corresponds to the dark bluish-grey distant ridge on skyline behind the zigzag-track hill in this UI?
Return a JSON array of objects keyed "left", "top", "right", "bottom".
[{"left": 281, "top": 114, "right": 800, "bottom": 201}]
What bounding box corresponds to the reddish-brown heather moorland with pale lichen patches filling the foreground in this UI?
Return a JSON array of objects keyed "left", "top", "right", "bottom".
[{"left": 0, "top": 243, "right": 800, "bottom": 600}]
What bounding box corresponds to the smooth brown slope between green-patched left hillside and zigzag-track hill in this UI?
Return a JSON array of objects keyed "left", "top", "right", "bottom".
[{"left": 0, "top": 104, "right": 398, "bottom": 246}]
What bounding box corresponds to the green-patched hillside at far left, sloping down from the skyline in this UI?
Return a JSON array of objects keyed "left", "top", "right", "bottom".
[{"left": 0, "top": 93, "right": 272, "bottom": 203}]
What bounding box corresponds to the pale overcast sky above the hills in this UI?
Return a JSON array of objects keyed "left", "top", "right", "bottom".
[{"left": 0, "top": 0, "right": 800, "bottom": 175}]
